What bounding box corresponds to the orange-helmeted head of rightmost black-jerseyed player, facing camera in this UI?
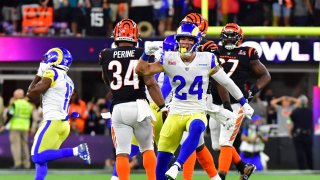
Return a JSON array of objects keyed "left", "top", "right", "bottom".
[{"left": 220, "top": 23, "right": 243, "bottom": 50}]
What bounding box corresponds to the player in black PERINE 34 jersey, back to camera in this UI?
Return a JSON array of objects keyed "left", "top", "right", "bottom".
[{"left": 99, "top": 19, "right": 164, "bottom": 180}]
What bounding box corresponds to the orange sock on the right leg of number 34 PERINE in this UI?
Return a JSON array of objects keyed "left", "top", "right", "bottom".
[{"left": 143, "top": 150, "right": 157, "bottom": 180}]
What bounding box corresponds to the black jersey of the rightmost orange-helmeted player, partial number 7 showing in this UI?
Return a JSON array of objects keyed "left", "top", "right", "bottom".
[{"left": 211, "top": 46, "right": 259, "bottom": 104}]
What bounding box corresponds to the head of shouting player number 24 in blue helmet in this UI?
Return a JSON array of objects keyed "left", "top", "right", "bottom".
[{"left": 175, "top": 23, "right": 201, "bottom": 58}]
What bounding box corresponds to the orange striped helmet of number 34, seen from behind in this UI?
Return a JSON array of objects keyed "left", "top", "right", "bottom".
[{"left": 113, "top": 19, "right": 139, "bottom": 45}]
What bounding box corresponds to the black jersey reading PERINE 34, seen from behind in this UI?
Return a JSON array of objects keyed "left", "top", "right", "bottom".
[{"left": 99, "top": 46, "right": 147, "bottom": 105}]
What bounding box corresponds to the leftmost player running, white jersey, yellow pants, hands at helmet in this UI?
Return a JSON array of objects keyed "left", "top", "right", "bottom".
[{"left": 27, "top": 47, "right": 91, "bottom": 180}]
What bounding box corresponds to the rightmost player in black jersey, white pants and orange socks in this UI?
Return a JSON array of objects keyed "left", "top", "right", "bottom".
[{"left": 209, "top": 23, "right": 271, "bottom": 180}]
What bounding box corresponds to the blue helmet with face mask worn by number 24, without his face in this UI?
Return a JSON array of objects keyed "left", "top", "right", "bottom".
[{"left": 175, "top": 23, "right": 201, "bottom": 57}]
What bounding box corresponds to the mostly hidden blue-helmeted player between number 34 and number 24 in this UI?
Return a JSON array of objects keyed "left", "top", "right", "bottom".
[{"left": 111, "top": 35, "right": 175, "bottom": 180}]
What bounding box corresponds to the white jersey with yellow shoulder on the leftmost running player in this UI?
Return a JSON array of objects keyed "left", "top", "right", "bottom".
[{"left": 42, "top": 68, "right": 74, "bottom": 120}]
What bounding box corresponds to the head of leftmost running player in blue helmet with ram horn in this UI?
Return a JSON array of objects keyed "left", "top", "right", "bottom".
[{"left": 43, "top": 47, "right": 72, "bottom": 71}]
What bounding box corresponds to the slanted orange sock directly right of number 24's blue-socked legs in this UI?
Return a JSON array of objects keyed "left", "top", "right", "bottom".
[{"left": 197, "top": 146, "right": 218, "bottom": 178}]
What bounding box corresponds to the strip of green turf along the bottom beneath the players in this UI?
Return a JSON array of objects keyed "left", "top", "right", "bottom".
[{"left": 0, "top": 170, "right": 320, "bottom": 180}]
